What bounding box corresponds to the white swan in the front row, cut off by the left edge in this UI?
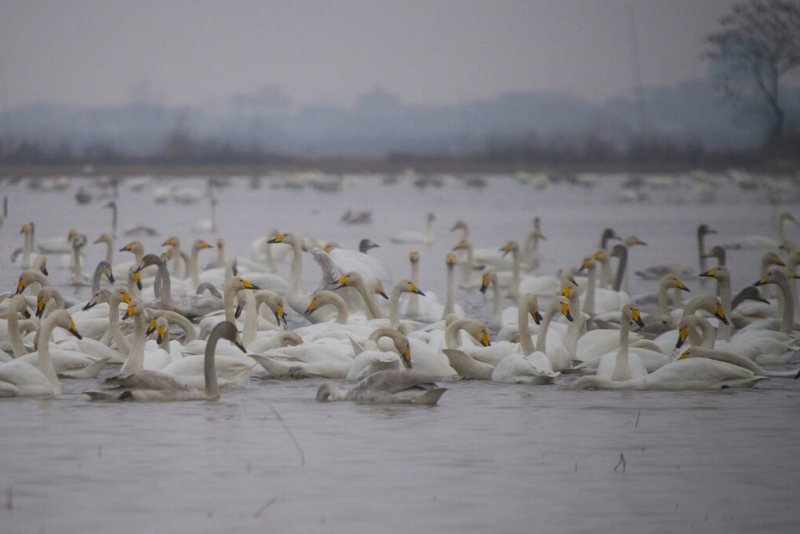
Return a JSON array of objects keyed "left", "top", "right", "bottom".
[{"left": 0, "top": 310, "right": 80, "bottom": 397}]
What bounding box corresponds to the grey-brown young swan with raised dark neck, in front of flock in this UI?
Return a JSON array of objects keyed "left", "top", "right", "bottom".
[{"left": 85, "top": 321, "right": 245, "bottom": 402}]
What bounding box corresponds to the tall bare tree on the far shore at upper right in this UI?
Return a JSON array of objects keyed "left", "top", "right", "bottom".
[{"left": 704, "top": 0, "right": 800, "bottom": 142}]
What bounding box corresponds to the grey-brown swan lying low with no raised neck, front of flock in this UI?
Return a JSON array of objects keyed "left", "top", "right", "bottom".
[{"left": 317, "top": 369, "right": 447, "bottom": 405}]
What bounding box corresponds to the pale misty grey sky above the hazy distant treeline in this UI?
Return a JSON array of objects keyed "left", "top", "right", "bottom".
[{"left": 0, "top": 0, "right": 734, "bottom": 110}]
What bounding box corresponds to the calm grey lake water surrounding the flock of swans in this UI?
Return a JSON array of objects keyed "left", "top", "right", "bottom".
[{"left": 0, "top": 177, "right": 800, "bottom": 533}]
